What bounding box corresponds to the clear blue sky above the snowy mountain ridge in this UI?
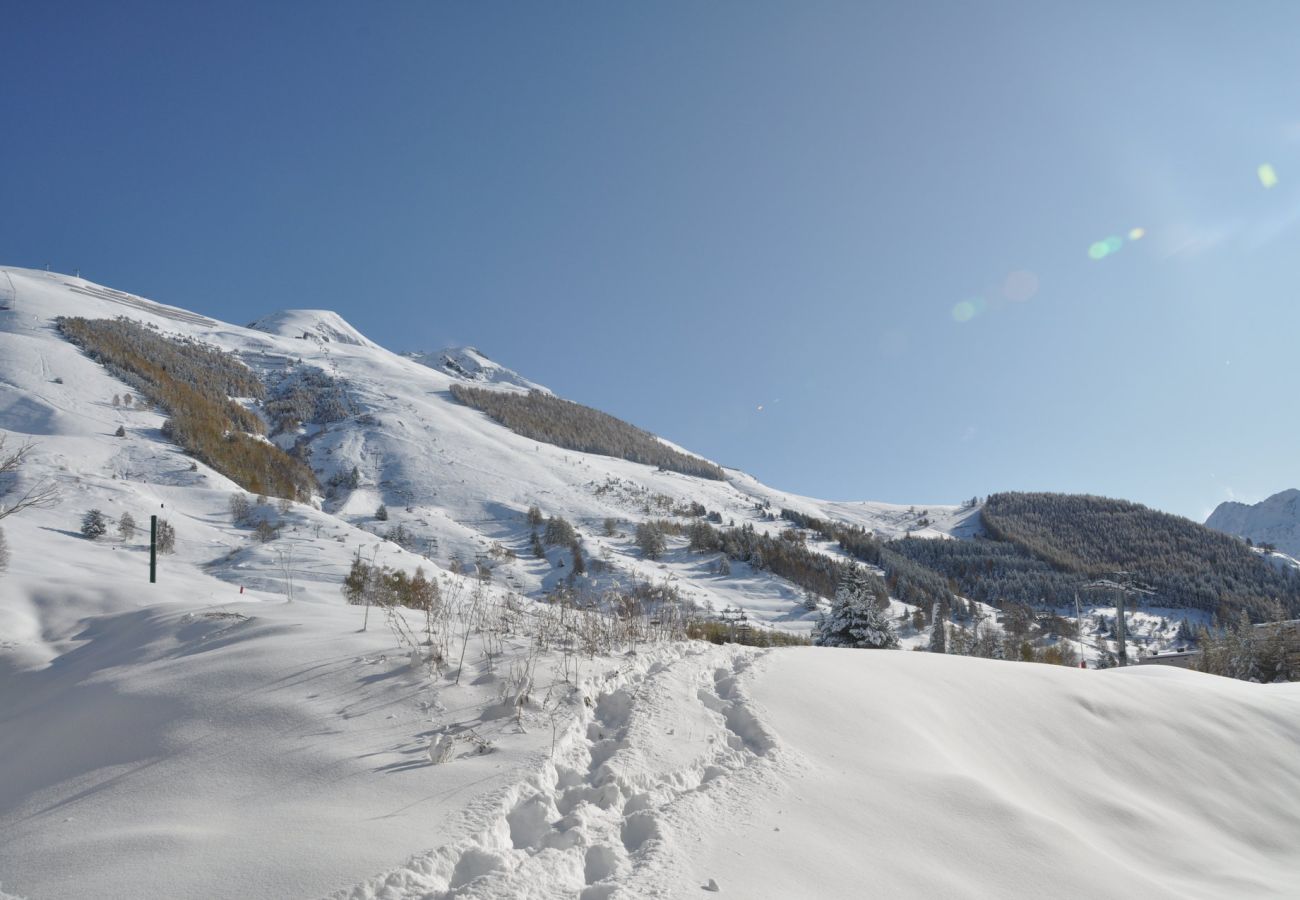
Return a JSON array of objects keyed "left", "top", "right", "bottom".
[{"left": 0, "top": 0, "right": 1300, "bottom": 518}]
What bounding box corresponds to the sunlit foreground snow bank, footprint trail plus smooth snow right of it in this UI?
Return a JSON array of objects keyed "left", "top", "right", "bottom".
[{"left": 319, "top": 648, "right": 1300, "bottom": 900}]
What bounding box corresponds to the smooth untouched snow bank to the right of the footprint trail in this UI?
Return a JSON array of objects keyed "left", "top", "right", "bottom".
[{"left": 681, "top": 648, "right": 1300, "bottom": 897}]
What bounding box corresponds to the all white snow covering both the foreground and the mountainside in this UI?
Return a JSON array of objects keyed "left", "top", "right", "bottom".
[{"left": 0, "top": 269, "right": 1300, "bottom": 900}]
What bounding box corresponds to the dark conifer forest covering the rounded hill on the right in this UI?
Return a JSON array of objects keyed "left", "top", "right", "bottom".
[{"left": 781, "top": 493, "right": 1300, "bottom": 623}]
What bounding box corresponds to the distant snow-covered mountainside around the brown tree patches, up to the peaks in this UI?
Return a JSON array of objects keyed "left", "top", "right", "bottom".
[{"left": 0, "top": 269, "right": 978, "bottom": 632}]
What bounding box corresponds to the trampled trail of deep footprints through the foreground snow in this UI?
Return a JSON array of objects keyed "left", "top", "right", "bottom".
[{"left": 338, "top": 649, "right": 776, "bottom": 900}]
